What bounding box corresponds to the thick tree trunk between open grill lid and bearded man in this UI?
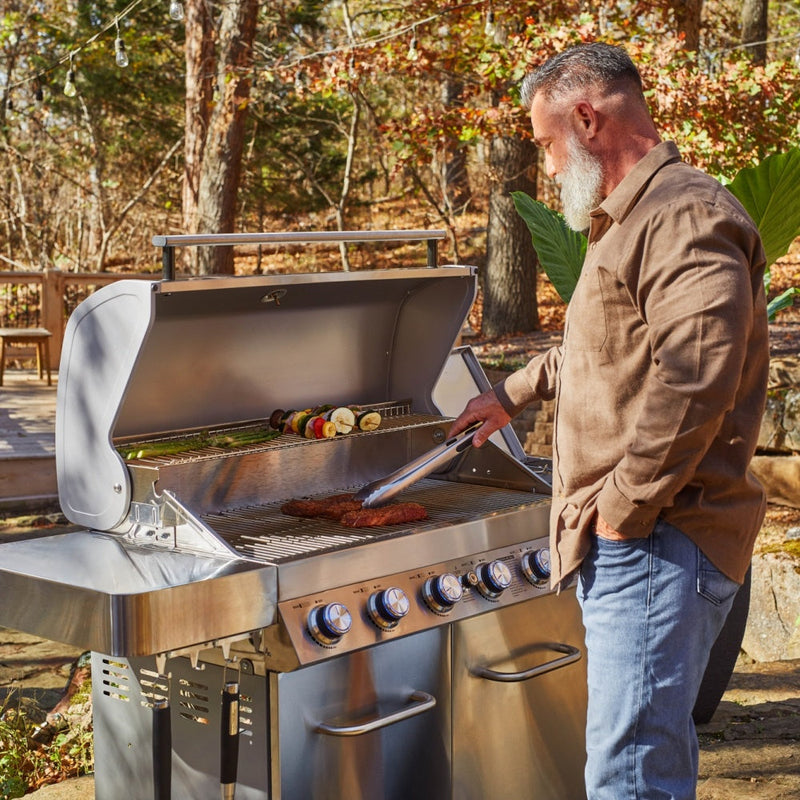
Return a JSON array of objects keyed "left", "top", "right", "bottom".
[{"left": 482, "top": 136, "right": 539, "bottom": 337}]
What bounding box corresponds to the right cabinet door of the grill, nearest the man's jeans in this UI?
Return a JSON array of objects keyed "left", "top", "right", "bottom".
[{"left": 453, "top": 588, "right": 587, "bottom": 800}]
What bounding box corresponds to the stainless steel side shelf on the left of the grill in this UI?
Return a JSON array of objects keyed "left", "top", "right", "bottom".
[{"left": 0, "top": 531, "right": 277, "bottom": 656}]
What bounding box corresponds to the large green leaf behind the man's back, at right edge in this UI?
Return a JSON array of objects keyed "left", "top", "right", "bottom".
[{"left": 728, "top": 147, "right": 800, "bottom": 268}]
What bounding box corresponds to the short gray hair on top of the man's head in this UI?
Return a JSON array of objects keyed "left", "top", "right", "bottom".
[{"left": 520, "top": 42, "right": 642, "bottom": 111}]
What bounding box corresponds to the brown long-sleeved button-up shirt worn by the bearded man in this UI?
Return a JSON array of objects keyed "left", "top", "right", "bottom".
[{"left": 495, "top": 142, "right": 769, "bottom": 585}]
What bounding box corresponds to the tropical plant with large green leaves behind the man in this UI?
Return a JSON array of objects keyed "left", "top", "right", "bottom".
[{"left": 512, "top": 147, "right": 800, "bottom": 321}]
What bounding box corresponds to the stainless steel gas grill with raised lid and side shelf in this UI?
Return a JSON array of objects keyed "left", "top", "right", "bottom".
[{"left": 0, "top": 231, "right": 586, "bottom": 800}]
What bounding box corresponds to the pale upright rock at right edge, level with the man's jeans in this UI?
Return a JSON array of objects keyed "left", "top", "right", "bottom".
[{"left": 742, "top": 552, "right": 800, "bottom": 661}]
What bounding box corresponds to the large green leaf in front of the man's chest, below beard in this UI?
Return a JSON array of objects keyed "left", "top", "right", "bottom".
[{"left": 511, "top": 192, "right": 586, "bottom": 303}]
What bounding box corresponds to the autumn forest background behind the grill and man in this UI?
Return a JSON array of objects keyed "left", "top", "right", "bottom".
[{"left": 0, "top": 0, "right": 800, "bottom": 337}]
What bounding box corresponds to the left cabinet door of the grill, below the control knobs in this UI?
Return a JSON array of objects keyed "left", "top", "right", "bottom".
[{"left": 269, "top": 627, "right": 450, "bottom": 800}]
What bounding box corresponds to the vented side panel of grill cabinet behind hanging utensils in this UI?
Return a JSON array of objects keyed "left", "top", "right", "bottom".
[{"left": 92, "top": 653, "right": 270, "bottom": 800}]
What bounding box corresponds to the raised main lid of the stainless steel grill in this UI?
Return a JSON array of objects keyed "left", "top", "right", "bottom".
[{"left": 56, "top": 244, "right": 476, "bottom": 530}]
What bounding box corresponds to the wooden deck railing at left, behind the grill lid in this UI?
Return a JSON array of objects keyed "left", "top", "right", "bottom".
[{"left": 0, "top": 269, "right": 154, "bottom": 369}]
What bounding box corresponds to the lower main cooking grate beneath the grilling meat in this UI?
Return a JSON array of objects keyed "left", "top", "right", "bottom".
[{"left": 203, "top": 478, "right": 548, "bottom": 565}]
